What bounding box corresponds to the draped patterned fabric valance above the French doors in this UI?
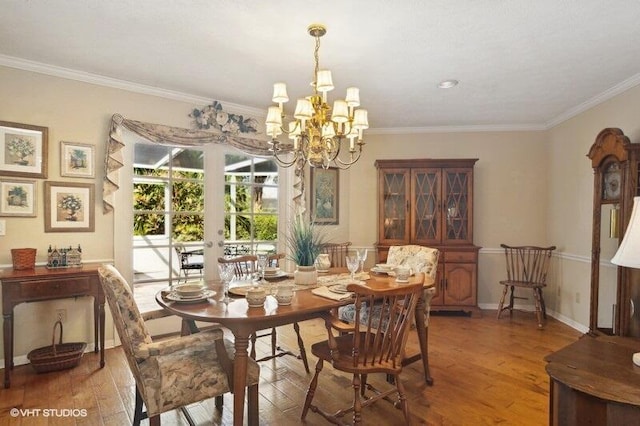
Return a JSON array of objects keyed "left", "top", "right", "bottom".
[{"left": 102, "top": 114, "right": 271, "bottom": 214}]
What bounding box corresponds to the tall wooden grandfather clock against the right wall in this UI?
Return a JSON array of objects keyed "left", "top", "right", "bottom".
[{"left": 587, "top": 128, "right": 640, "bottom": 336}]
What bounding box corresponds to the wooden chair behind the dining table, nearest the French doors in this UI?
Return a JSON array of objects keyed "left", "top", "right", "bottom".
[{"left": 218, "top": 253, "right": 311, "bottom": 373}]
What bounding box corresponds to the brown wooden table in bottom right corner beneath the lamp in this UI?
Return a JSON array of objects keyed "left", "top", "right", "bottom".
[{"left": 545, "top": 336, "right": 640, "bottom": 425}]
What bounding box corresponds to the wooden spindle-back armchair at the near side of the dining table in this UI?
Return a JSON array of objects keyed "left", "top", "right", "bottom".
[{"left": 301, "top": 274, "right": 424, "bottom": 425}]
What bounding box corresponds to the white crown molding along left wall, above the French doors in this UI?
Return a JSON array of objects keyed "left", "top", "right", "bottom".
[{"left": 0, "top": 55, "right": 266, "bottom": 117}]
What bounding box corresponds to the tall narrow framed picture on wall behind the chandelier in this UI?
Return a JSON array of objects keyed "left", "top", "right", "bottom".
[{"left": 310, "top": 167, "right": 340, "bottom": 225}]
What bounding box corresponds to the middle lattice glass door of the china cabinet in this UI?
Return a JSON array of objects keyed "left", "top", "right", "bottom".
[{"left": 411, "top": 169, "right": 442, "bottom": 244}]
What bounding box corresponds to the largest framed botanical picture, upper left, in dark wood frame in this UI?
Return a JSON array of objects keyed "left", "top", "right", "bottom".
[{"left": 0, "top": 121, "right": 49, "bottom": 179}]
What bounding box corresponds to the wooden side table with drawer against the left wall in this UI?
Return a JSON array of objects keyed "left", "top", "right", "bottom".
[{"left": 0, "top": 264, "right": 104, "bottom": 389}]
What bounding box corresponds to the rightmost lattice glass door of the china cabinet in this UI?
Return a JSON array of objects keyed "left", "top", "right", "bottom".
[{"left": 442, "top": 169, "right": 473, "bottom": 243}]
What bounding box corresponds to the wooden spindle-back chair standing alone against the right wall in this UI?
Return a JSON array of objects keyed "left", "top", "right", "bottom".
[{"left": 498, "top": 244, "right": 556, "bottom": 328}]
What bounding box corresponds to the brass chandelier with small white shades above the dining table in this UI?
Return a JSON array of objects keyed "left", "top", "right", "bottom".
[{"left": 266, "top": 24, "right": 369, "bottom": 169}]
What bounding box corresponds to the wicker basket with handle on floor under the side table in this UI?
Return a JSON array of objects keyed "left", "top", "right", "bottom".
[{"left": 27, "top": 321, "right": 87, "bottom": 373}]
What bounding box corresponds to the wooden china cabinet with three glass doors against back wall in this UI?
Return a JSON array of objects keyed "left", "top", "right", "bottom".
[{"left": 375, "top": 159, "right": 480, "bottom": 312}]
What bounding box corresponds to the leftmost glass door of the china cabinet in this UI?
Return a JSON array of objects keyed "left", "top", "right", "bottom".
[{"left": 380, "top": 169, "right": 410, "bottom": 244}]
